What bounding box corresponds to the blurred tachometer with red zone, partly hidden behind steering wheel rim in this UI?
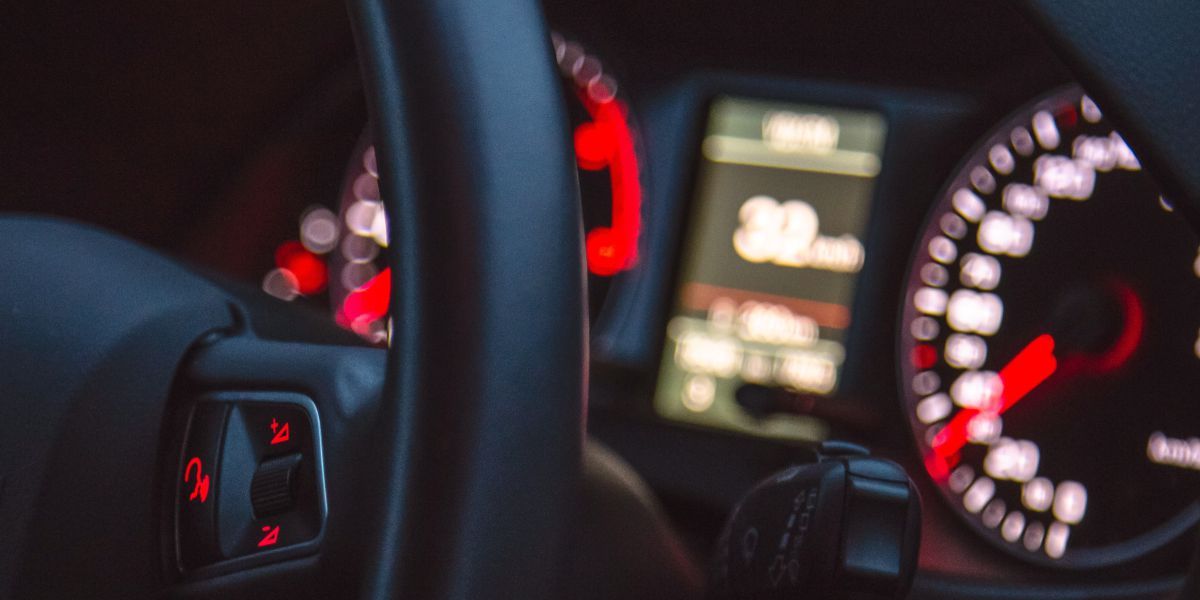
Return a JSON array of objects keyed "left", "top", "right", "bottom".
[{"left": 263, "top": 34, "right": 642, "bottom": 343}]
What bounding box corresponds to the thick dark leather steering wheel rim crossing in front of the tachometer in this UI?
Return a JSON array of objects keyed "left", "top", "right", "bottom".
[{"left": 349, "top": 0, "right": 587, "bottom": 600}]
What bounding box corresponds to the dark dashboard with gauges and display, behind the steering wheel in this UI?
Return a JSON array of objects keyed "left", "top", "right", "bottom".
[{"left": 0, "top": 0, "right": 1200, "bottom": 598}]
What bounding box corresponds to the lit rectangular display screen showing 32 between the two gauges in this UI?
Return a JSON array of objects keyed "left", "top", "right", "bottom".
[{"left": 655, "top": 97, "right": 886, "bottom": 439}]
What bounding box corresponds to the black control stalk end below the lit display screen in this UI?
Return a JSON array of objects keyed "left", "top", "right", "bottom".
[{"left": 709, "top": 442, "right": 920, "bottom": 600}]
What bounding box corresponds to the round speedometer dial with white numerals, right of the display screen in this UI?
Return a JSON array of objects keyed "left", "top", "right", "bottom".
[{"left": 899, "top": 88, "right": 1200, "bottom": 568}]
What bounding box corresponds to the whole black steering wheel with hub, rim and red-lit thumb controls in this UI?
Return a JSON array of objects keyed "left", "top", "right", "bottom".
[{"left": 0, "top": 0, "right": 1200, "bottom": 600}]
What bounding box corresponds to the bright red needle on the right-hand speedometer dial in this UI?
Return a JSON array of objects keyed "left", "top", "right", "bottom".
[{"left": 931, "top": 334, "right": 1058, "bottom": 460}]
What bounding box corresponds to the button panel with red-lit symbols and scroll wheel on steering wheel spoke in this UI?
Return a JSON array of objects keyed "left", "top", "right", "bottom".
[{"left": 176, "top": 392, "right": 326, "bottom": 570}]
